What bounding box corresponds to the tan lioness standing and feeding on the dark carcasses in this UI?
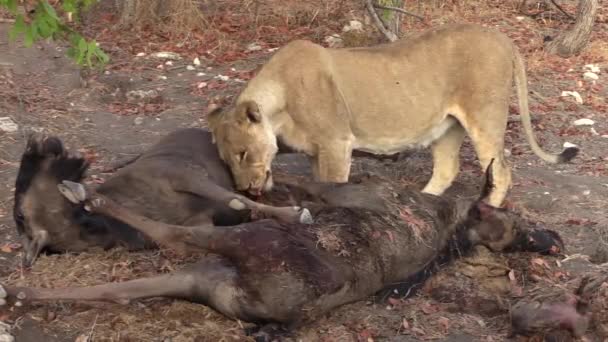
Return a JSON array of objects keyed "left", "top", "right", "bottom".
[{"left": 208, "top": 24, "right": 578, "bottom": 206}]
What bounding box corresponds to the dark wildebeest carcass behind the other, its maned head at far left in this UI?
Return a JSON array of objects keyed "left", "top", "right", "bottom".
[{"left": 13, "top": 128, "right": 310, "bottom": 265}]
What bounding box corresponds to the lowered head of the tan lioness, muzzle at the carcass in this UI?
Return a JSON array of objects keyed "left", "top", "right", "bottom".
[{"left": 207, "top": 101, "right": 278, "bottom": 195}]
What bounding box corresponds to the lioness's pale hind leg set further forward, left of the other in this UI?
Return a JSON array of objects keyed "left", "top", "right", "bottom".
[{"left": 422, "top": 122, "right": 466, "bottom": 196}]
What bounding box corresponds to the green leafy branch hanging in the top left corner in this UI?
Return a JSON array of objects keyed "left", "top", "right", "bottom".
[{"left": 0, "top": 0, "right": 110, "bottom": 68}]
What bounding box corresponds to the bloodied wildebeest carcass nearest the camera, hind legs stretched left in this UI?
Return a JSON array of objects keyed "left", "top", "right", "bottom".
[{"left": 0, "top": 155, "right": 561, "bottom": 340}]
